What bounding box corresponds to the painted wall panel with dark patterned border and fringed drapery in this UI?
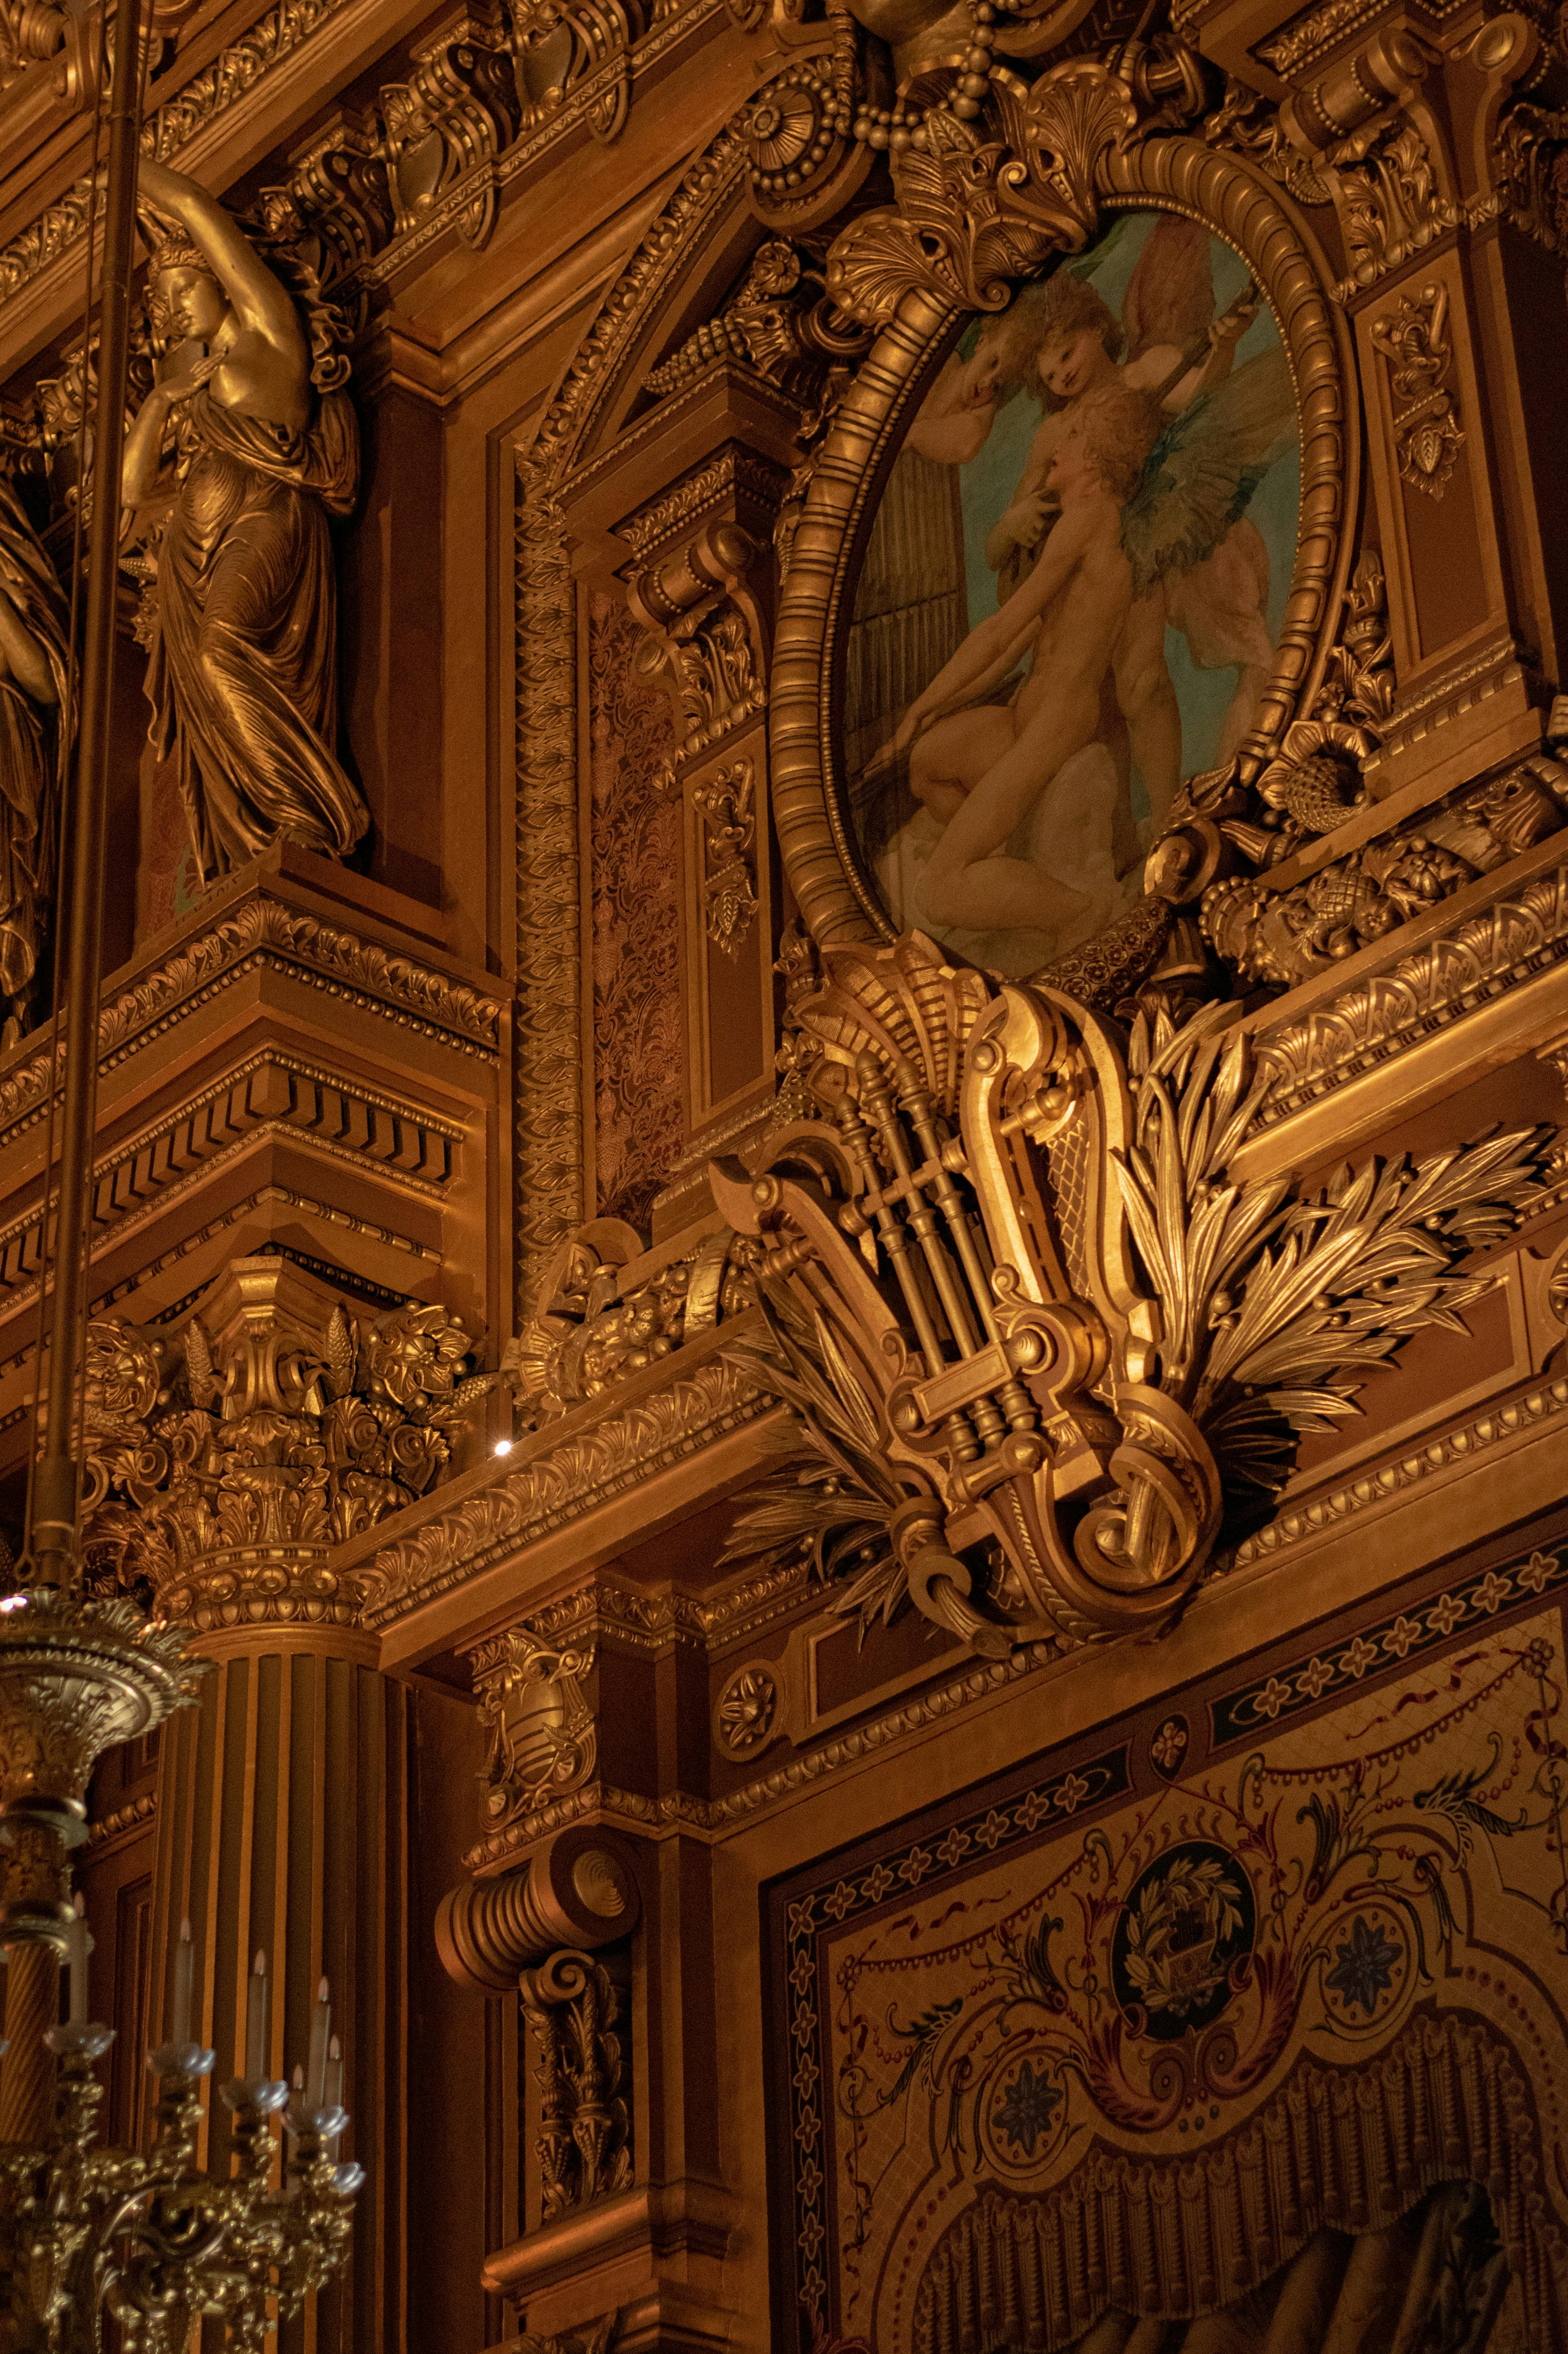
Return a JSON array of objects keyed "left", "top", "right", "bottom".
[{"left": 770, "top": 1546, "right": 1568, "bottom": 2354}]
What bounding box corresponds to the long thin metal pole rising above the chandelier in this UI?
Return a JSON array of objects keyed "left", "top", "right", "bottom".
[{"left": 28, "top": 0, "right": 146, "bottom": 1586}]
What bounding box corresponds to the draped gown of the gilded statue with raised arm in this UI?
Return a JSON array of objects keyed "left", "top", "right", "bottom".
[{"left": 146, "top": 384, "right": 370, "bottom": 876}]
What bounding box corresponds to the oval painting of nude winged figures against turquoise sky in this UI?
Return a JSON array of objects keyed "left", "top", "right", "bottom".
[{"left": 845, "top": 212, "right": 1297, "bottom": 974}]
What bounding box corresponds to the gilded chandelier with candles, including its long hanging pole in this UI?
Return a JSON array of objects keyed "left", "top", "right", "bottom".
[{"left": 0, "top": 0, "right": 365, "bottom": 2354}]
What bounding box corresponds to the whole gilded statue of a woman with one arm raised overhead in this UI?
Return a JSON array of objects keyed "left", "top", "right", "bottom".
[{"left": 125, "top": 158, "right": 370, "bottom": 876}]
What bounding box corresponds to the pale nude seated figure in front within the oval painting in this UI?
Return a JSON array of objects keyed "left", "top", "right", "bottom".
[{"left": 888, "top": 384, "right": 1161, "bottom": 949}]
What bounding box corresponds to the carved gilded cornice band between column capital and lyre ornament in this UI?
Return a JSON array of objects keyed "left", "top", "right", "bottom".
[{"left": 360, "top": 1356, "right": 772, "bottom": 1627}]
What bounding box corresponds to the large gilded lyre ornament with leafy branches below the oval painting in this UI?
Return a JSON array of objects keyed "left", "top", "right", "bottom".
[{"left": 711, "top": 932, "right": 1554, "bottom": 1652}]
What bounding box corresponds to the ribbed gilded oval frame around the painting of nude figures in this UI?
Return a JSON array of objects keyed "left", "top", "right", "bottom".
[{"left": 770, "top": 137, "right": 1361, "bottom": 949}]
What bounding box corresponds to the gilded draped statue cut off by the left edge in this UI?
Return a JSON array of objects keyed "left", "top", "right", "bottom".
[{"left": 0, "top": 475, "right": 71, "bottom": 1045}]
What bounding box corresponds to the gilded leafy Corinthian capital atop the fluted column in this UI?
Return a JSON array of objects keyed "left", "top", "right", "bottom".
[{"left": 82, "top": 1257, "right": 497, "bottom": 1629}]
